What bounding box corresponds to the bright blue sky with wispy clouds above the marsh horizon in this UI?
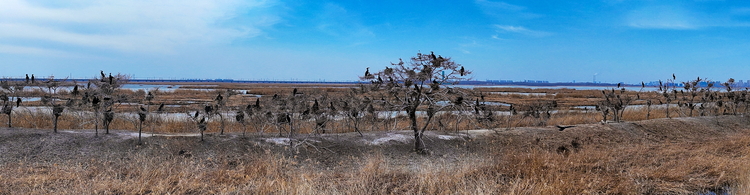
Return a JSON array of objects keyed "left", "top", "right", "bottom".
[{"left": 0, "top": 0, "right": 750, "bottom": 83}]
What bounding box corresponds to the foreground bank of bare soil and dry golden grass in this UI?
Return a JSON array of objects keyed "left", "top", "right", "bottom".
[{"left": 0, "top": 116, "right": 750, "bottom": 194}]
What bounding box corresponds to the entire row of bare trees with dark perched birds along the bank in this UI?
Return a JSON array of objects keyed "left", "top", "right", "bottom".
[{"left": 5, "top": 57, "right": 750, "bottom": 152}]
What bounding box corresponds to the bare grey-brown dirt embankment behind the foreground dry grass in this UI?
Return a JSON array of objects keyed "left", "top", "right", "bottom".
[{"left": 0, "top": 116, "right": 750, "bottom": 194}]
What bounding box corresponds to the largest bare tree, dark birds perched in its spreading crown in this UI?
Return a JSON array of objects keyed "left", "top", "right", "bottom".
[{"left": 360, "top": 53, "right": 471, "bottom": 153}]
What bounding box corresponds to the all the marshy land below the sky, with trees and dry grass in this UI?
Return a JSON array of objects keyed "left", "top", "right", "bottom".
[{"left": 0, "top": 64, "right": 750, "bottom": 194}]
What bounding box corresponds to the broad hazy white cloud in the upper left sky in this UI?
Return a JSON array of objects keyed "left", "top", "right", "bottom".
[{"left": 0, "top": 0, "right": 278, "bottom": 53}]
